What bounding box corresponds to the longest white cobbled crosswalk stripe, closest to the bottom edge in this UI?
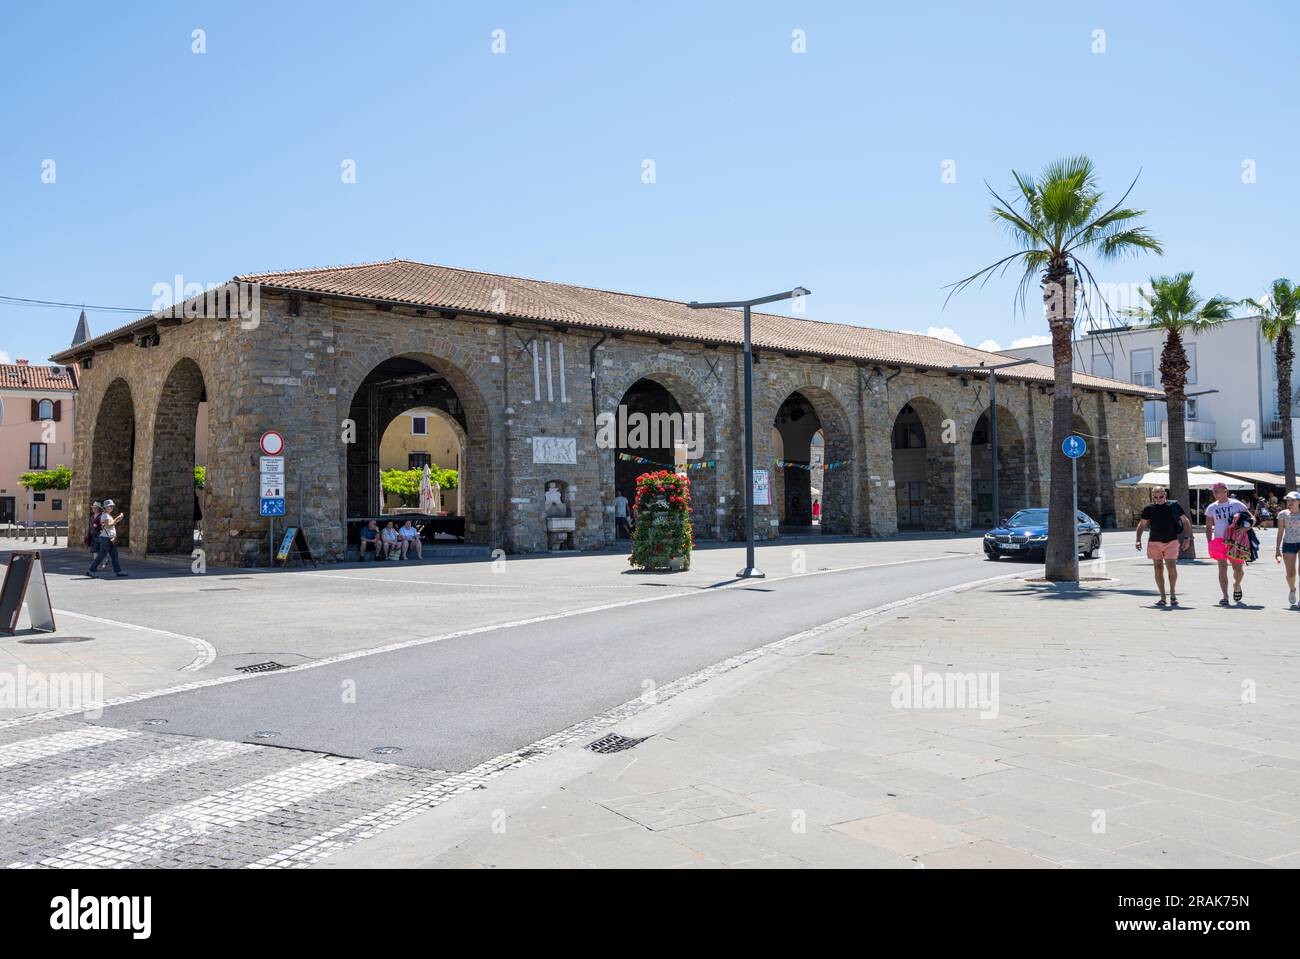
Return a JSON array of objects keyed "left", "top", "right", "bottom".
[{"left": 9, "top": 758, "right": 387, "bottom": 869}]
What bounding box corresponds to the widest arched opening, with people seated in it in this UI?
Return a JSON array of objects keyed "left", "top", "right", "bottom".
[{"left": 346, "top": 356, "right": 473, "bottom": 546}]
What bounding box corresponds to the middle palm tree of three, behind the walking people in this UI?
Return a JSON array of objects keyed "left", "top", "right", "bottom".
[{"left": 1121, "top": 273, "right": 1236, "bottom": 535}]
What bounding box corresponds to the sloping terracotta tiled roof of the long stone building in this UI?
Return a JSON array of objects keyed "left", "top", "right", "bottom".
[{"left": 55, "top": 260, "right": 1160, "bottom": 396}]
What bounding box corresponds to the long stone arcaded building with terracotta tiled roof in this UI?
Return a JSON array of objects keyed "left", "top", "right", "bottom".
[{"left": 53, "top": 260, "right": 1158, "bottom": 565}]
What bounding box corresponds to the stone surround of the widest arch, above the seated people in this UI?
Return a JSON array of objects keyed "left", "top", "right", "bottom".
[{"left": 335, "top": 343, "right": 501, "bottom": 546}]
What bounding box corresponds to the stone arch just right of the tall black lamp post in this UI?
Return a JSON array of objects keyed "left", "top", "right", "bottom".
[{"left": 754, "top": 378, "right": 862, "bottom": 534}]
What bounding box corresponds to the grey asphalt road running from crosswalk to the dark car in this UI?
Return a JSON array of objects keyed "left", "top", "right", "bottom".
[{"left": 98, "top": 545, "right": 1032, "bottom": 772}]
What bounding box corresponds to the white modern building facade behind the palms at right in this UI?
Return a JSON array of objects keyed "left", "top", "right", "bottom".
[{"left": 1004, "top": 317, "right": 1300, "bottom": 473}]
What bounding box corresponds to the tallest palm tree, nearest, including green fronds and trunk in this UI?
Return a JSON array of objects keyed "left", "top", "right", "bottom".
[{"left": 948, "top": 156, "right": 1162, "bottom": 582}]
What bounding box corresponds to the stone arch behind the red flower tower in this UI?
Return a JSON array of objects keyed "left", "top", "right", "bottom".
[{"left": 595, "top": 364, "right": 723, "bottom": 542}]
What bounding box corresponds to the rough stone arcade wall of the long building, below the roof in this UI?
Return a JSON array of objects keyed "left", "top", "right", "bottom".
[{"left": 70, "top": 290, "right": 1145, "bottom": 565}]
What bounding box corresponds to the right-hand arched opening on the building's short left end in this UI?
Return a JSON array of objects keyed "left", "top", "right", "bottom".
[{"left": 148, "top": 359, "right": 208, "bottom": 554}]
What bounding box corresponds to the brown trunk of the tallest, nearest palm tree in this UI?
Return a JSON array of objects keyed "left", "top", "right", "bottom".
[{"left": 1043, "top": 262, "right": 1078, "bottom": 582}]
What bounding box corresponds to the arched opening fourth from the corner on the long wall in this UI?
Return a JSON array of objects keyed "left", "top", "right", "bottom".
[{"left": 891, "top": 396, "right": 957, "bottom": 530}]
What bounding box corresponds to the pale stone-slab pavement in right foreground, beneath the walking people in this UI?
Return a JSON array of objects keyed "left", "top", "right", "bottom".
[{"left": 333, "top": 561, "right": 1300, "bottom": 868}]
